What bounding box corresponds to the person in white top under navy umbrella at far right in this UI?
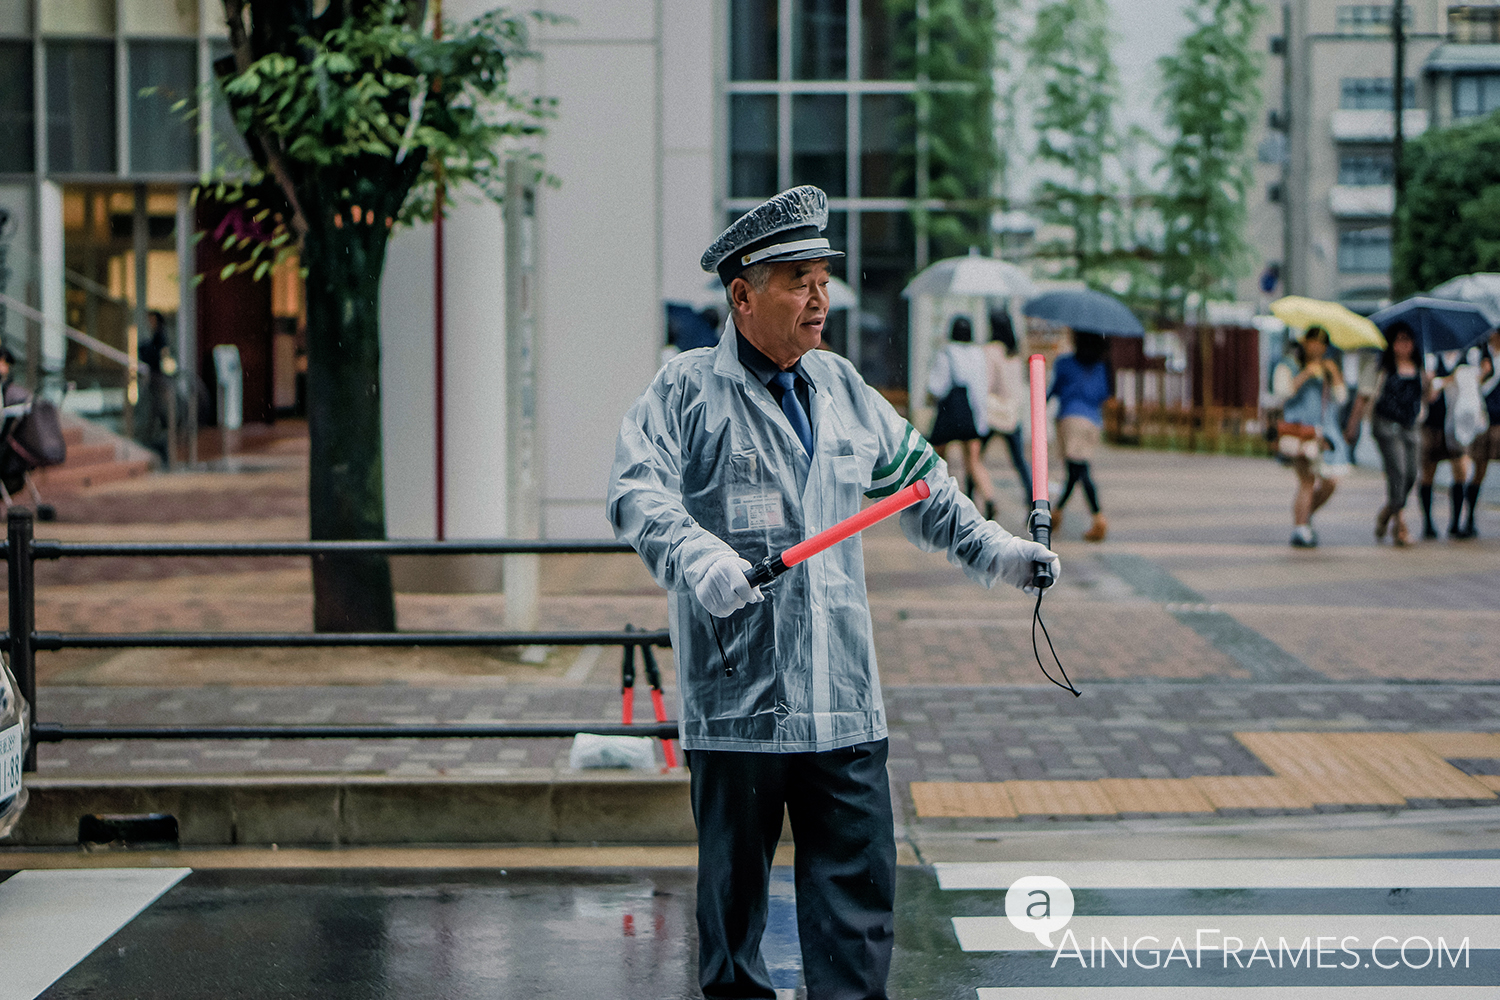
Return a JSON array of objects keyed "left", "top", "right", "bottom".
[{"left": 1370, "top": 295, "right": 1493, "bottom": 540}]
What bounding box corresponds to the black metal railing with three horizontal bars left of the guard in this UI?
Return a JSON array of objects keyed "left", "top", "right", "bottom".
[{"left": 0, "top": 508, "right": 678, "bottom": 771}]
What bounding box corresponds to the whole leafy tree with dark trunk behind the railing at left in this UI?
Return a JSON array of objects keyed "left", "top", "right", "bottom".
[{"left": 212, "top": 0, "right": 548, "bottom": 631}]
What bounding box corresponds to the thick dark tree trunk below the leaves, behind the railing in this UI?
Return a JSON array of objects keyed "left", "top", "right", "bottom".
[{"left": 303, "top": 210, "right": 396, "bottom": 631}]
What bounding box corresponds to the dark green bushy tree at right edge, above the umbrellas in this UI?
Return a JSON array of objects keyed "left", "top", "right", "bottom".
[{"left": 1391, "top": 111, "right": 1500, "bottom": 297}]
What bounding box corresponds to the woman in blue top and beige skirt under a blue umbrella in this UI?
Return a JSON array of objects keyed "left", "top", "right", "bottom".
[{"left": 1022, "top": 291, "right": 1146, "bottom": 541}]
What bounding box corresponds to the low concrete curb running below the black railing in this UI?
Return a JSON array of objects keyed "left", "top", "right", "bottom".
[{"left": 6, "top": 772, "right": 696, "bottom": 847}]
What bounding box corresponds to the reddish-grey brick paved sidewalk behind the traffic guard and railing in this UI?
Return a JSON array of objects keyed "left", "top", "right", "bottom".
[{"left": 11, "top": 431, "right": 1500, "bottom": 828}]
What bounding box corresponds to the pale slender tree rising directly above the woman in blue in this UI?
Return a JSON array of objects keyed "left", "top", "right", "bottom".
[{"left": 1026, "top": 0, "right": 1119, "bottom": 279}]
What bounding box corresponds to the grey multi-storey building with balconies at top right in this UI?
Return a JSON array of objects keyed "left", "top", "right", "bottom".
[{"left": 1242, "top": 0, "right": 1500, "bottom": 312}]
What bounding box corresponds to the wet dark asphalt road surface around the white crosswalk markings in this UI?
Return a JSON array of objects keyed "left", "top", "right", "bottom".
[{"left": 0, "top": 859, "right": 1500, "bottom": 1000}]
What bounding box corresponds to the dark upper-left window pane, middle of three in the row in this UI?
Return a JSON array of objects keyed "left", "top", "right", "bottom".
[{"left": 47, "top": 42, "right": 116, "bottom": 174}]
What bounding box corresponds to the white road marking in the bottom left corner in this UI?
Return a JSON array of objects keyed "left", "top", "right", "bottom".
[{"left": 0, "top": 868, "right": 192, "bottom": 1000}]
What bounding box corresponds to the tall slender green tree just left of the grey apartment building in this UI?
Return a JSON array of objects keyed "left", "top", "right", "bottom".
[{"left": 1157, "top": 0, "right": 1265, "bottom": 319}]
